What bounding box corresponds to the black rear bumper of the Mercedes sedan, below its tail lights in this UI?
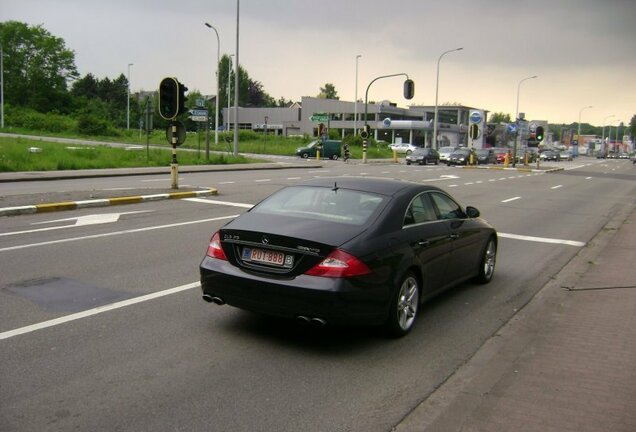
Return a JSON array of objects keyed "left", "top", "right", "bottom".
[{"left": 200, "top": 257, "right": 389, "bottom": 325}]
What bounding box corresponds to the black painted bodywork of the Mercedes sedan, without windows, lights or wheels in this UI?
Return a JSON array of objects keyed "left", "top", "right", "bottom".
[{"left": 201, "top": 177, "right": 496, "bottom": 324}]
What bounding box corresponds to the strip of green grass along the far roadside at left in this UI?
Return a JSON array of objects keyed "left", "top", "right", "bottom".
[{"left": 0, "top": 137, "right": 256, "bottom": 172}]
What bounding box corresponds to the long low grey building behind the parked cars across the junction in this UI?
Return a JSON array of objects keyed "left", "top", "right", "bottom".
[{"left": 223, "top": 96, "right": 488, "bottom": 148}]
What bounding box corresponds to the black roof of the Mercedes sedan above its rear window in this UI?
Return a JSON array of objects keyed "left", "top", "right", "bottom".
[{"left": 299, "top": 176, "right": 441, "bottom": 195}]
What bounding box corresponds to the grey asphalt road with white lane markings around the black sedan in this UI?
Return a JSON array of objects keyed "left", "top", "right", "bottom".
[{"left": 0, "top": 158, "right": 636, "bottom": 431}]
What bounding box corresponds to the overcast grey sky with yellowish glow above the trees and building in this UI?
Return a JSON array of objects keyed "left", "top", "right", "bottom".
[{"left": 0, "top": 0, "right": 636, "bottom": 126}]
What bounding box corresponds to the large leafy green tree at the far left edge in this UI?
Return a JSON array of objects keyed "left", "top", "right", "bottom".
[{"left": 0, "top": 21, "right": 78, "bottom": 112}]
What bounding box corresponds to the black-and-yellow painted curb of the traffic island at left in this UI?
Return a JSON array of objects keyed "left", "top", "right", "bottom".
[{"left": 0, "top": 188, "right": 218, "bottom": 216}]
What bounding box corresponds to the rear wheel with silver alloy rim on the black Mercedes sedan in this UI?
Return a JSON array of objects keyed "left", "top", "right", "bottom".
[{"left": 385, "top": 272, "right": 420, "bottom": 337}]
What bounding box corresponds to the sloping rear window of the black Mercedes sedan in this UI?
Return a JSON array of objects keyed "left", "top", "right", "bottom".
[{"left": 251, "top": 185, "right": 385, "bottom": 225}]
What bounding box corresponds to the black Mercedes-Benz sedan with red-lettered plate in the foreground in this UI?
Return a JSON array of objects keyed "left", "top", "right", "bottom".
[{"left": 200, "top": 177, "right": 497, "bottom": 336}]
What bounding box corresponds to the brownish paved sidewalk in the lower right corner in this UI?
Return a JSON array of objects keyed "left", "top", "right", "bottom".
[{"left": 394, "top": 203, "right": 636, "bottom": 432}]
